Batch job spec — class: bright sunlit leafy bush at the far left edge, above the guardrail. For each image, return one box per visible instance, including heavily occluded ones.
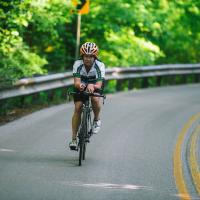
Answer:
[0,1,47,87]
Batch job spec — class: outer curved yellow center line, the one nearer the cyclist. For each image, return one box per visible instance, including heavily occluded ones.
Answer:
[173,113,200,200]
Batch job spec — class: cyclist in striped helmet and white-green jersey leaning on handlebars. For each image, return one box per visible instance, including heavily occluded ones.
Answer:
[69,42,105,150]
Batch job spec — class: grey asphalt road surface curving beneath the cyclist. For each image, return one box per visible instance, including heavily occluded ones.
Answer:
[0,84,200,200]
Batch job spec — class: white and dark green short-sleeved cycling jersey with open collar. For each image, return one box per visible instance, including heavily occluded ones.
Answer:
[73,59,105,84]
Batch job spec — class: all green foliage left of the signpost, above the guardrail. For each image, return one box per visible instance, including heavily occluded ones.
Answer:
[0,0,73,88]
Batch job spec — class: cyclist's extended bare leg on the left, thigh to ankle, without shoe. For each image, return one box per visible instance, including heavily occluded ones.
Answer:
[72,101,83,140]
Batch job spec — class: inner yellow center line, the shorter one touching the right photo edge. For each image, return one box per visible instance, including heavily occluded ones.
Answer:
[190,125,200,195]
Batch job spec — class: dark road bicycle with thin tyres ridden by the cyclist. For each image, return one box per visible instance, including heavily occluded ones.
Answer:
[68,91,106,166]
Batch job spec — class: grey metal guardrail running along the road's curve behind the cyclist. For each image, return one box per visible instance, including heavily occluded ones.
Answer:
[0,64,200,100]
